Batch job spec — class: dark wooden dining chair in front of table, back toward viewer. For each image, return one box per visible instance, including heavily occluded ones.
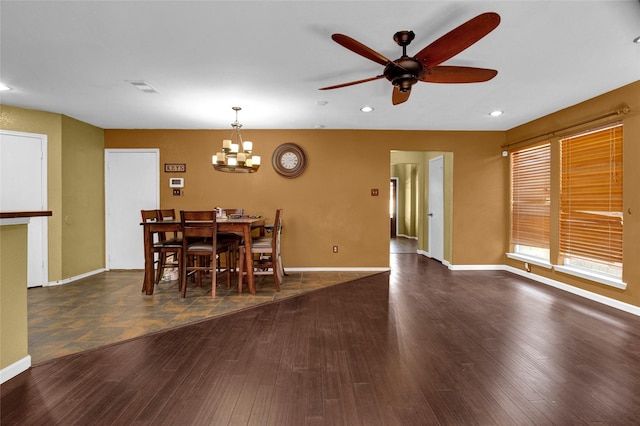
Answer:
[180,210,231,297]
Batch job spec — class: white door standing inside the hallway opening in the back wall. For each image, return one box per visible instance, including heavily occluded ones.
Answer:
[428,155,444,262]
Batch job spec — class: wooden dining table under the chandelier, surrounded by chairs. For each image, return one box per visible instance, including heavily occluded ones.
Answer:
[140,216,265,295]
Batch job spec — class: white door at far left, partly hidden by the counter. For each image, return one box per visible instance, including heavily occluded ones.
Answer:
[0,130,49,287]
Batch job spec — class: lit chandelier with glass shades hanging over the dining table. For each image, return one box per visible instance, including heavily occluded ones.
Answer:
[211,107,260,173]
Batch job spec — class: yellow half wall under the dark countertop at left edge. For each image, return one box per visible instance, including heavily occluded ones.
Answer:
[0,225,28,369]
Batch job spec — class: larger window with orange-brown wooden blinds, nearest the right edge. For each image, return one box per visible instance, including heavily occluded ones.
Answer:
[559,125,622,277]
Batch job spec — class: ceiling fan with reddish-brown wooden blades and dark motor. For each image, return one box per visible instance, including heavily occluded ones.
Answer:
[319,12,500,105]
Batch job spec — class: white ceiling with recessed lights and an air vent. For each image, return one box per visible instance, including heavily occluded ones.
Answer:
[0,0,640,130]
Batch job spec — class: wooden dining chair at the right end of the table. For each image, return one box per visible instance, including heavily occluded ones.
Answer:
[238,209,284,293]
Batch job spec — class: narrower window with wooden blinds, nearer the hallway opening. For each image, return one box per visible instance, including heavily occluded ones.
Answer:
[511,142,551,261]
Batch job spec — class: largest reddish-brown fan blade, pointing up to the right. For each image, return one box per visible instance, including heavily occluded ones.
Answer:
[414,12,500,69]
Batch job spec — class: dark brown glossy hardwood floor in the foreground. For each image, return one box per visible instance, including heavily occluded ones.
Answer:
[1,254,640,426]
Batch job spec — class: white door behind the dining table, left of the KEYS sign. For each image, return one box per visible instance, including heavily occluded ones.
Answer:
[105,149,160,270]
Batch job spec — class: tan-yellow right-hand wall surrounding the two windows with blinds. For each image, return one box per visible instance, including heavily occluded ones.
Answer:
[503,82,640,306]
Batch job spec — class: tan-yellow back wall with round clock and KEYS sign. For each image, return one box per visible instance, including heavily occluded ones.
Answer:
[105,129,506,268]
